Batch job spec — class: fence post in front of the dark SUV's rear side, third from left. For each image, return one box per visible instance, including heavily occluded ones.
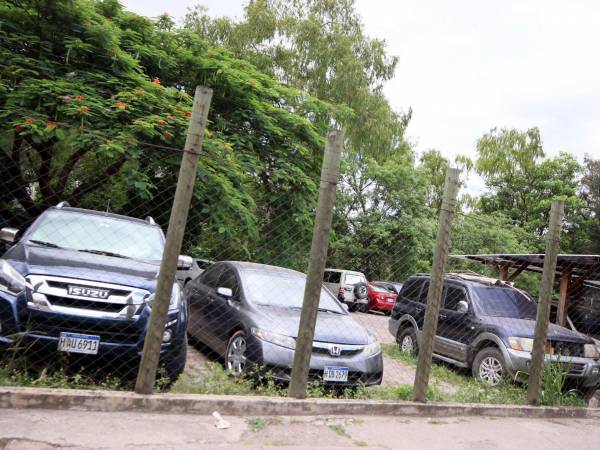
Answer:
[413,168,460,403]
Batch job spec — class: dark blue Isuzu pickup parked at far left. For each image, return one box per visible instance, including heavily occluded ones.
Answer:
[0,202,187,380]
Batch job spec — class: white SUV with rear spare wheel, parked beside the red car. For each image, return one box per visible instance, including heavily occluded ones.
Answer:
[323,269,369,312]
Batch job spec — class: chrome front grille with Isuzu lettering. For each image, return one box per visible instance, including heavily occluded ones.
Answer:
[27,275,150,319]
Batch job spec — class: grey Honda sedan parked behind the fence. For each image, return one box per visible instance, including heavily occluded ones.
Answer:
[185,261,383,386]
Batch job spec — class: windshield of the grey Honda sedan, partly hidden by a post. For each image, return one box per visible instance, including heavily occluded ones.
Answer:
[242,270,345,314]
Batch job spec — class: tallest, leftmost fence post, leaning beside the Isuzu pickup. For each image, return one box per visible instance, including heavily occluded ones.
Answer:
[135,86,212,394]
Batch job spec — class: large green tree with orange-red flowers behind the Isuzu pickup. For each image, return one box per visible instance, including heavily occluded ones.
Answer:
[0,0,336,259]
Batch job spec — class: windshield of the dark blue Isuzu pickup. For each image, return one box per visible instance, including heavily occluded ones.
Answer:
[28,211,164,261]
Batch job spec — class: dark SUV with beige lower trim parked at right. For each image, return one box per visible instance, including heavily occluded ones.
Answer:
[389,274,600,392]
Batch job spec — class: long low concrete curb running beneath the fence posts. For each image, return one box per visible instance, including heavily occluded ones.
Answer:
[0,388,600,419]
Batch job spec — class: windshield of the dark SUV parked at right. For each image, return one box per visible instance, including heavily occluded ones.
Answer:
[473,286,537,320]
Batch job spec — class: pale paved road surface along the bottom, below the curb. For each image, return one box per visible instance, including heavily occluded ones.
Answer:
[0,410,600,450]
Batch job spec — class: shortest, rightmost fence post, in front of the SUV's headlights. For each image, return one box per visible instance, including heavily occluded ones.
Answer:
[527,200,565,405]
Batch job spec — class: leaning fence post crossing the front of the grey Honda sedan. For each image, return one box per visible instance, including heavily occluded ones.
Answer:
[289,130,343,398]
